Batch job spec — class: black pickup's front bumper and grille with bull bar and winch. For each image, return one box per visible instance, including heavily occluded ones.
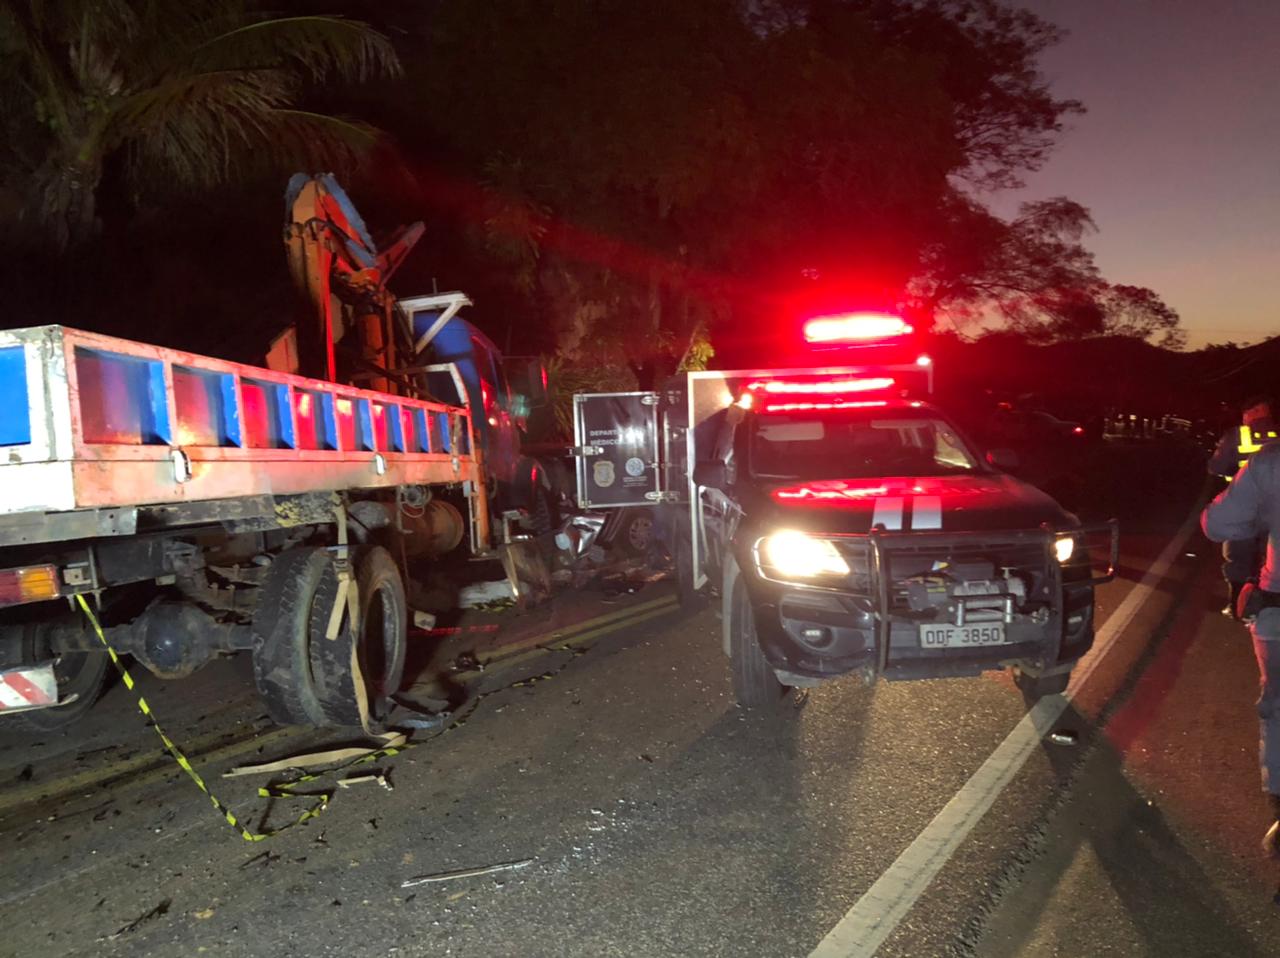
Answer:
[739,520,1119,685]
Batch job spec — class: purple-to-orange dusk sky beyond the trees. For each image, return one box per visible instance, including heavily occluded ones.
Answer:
[993,0,1280,348]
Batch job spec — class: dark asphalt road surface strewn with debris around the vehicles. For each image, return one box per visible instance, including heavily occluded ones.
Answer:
[0,438,1277,957]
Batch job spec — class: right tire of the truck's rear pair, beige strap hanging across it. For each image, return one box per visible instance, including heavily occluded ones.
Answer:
[311,547,408,726]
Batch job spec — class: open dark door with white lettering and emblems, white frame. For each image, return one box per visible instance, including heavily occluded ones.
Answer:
[573,392,662,508]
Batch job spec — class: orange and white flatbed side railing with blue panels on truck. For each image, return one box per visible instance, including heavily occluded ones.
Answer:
[0,325,481,516]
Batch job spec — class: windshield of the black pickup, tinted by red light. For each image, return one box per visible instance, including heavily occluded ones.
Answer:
[749,410,982,479]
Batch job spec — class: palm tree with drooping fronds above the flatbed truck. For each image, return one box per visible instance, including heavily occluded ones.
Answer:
[0,0,399,250]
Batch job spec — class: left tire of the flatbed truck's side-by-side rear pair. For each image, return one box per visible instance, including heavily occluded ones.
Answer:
[253,548,337,726]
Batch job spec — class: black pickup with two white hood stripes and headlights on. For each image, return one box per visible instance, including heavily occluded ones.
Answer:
[691,387,1117,706]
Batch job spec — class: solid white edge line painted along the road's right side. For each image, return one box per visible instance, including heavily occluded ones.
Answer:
[809,510,1199,958]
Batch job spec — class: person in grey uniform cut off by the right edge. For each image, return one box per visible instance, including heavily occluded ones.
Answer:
[1201,442,1280,857]
